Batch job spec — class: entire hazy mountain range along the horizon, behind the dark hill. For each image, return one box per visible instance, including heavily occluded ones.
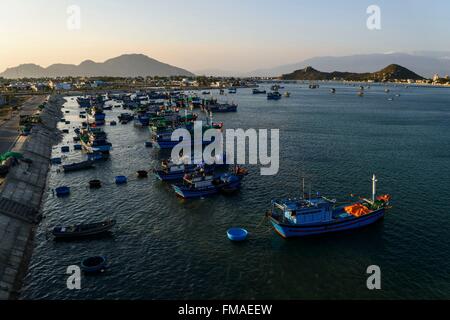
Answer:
[0,51,450,78]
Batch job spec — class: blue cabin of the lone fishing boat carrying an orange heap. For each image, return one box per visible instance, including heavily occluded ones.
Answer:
[272,197,334,224]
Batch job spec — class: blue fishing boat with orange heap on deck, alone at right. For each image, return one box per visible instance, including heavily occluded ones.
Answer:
[268,175,390,238]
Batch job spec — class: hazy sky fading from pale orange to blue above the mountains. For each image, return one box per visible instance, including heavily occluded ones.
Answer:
[0,0,450,71]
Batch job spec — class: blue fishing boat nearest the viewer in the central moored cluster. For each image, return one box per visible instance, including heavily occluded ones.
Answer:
[172,168,247,199]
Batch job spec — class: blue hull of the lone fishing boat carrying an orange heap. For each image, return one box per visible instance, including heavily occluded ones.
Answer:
[270,208,385,238]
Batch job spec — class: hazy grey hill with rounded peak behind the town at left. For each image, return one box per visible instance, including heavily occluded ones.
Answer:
[0,54,194,78]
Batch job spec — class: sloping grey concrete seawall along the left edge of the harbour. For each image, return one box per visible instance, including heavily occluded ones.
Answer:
[0,96,65,300]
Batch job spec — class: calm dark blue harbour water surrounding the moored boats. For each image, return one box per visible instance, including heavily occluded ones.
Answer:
[22,84,450,299]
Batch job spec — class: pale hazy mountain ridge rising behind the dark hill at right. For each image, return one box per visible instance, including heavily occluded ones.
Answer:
[247,52,450,78]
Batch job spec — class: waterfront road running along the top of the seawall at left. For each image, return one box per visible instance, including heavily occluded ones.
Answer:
[0,96,47,154]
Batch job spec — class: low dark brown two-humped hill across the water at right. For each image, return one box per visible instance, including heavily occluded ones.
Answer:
[281,64,424,82]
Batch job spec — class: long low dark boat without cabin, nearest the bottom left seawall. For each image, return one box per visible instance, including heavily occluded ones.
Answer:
[52,220,116,239]
